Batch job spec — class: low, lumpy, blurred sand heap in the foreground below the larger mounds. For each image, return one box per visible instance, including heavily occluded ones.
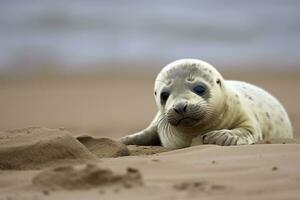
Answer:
[32,164,142,190]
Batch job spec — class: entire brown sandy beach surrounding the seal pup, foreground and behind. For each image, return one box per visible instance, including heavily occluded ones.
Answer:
[0,71,300,200]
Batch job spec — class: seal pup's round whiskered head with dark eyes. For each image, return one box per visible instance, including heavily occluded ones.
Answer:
[154,59,225,128]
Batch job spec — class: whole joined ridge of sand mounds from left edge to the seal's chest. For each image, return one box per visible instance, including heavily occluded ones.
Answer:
[0,127,167,170]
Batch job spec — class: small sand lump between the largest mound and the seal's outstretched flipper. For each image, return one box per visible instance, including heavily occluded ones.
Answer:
[77,135,130,158]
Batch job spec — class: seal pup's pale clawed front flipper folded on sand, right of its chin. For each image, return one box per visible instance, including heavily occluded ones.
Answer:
[202,128,255,146]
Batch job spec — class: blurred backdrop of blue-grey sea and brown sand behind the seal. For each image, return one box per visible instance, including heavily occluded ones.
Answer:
[0,0,300,137]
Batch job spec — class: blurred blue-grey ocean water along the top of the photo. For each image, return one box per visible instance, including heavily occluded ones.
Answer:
[0,0,300,70]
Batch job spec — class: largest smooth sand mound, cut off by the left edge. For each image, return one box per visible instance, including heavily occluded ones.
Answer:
[0,127,96,169]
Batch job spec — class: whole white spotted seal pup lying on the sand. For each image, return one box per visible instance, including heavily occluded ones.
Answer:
[121,59,293,149]
